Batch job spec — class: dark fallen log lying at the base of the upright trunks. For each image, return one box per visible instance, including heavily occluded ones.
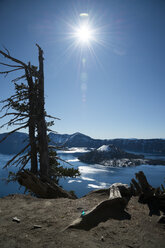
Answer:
[17,170,76,199]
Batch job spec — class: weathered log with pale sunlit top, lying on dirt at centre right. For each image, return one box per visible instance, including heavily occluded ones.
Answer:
[67,184,131,230]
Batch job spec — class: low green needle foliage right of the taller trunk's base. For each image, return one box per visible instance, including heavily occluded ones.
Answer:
[49,149,80,184]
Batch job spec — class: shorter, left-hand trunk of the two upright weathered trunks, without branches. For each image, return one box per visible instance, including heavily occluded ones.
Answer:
[25,66,38,174]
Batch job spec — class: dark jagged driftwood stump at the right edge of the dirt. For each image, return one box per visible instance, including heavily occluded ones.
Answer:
[131,171,165,216]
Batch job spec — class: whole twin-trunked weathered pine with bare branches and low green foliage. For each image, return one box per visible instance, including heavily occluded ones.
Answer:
[0,44,79,198]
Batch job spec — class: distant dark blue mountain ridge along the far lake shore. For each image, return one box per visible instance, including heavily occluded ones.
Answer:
[0,132,165,155]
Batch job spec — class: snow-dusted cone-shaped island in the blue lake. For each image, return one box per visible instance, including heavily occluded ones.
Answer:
[79,144,165,167]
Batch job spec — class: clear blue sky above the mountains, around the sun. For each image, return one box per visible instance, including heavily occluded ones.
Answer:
[0,0,165,138]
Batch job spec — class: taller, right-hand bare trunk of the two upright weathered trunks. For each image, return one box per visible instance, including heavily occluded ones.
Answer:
[37,45,49,177]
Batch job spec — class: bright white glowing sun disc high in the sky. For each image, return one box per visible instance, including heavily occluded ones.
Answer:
[75,25,93,44]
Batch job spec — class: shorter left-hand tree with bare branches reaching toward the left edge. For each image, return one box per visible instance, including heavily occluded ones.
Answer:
[0,51,37,171]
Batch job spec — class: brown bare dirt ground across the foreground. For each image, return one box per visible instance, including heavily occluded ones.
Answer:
[0,193,165,248]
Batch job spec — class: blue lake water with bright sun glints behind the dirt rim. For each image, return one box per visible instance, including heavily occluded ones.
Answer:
[0,153,165,197]
